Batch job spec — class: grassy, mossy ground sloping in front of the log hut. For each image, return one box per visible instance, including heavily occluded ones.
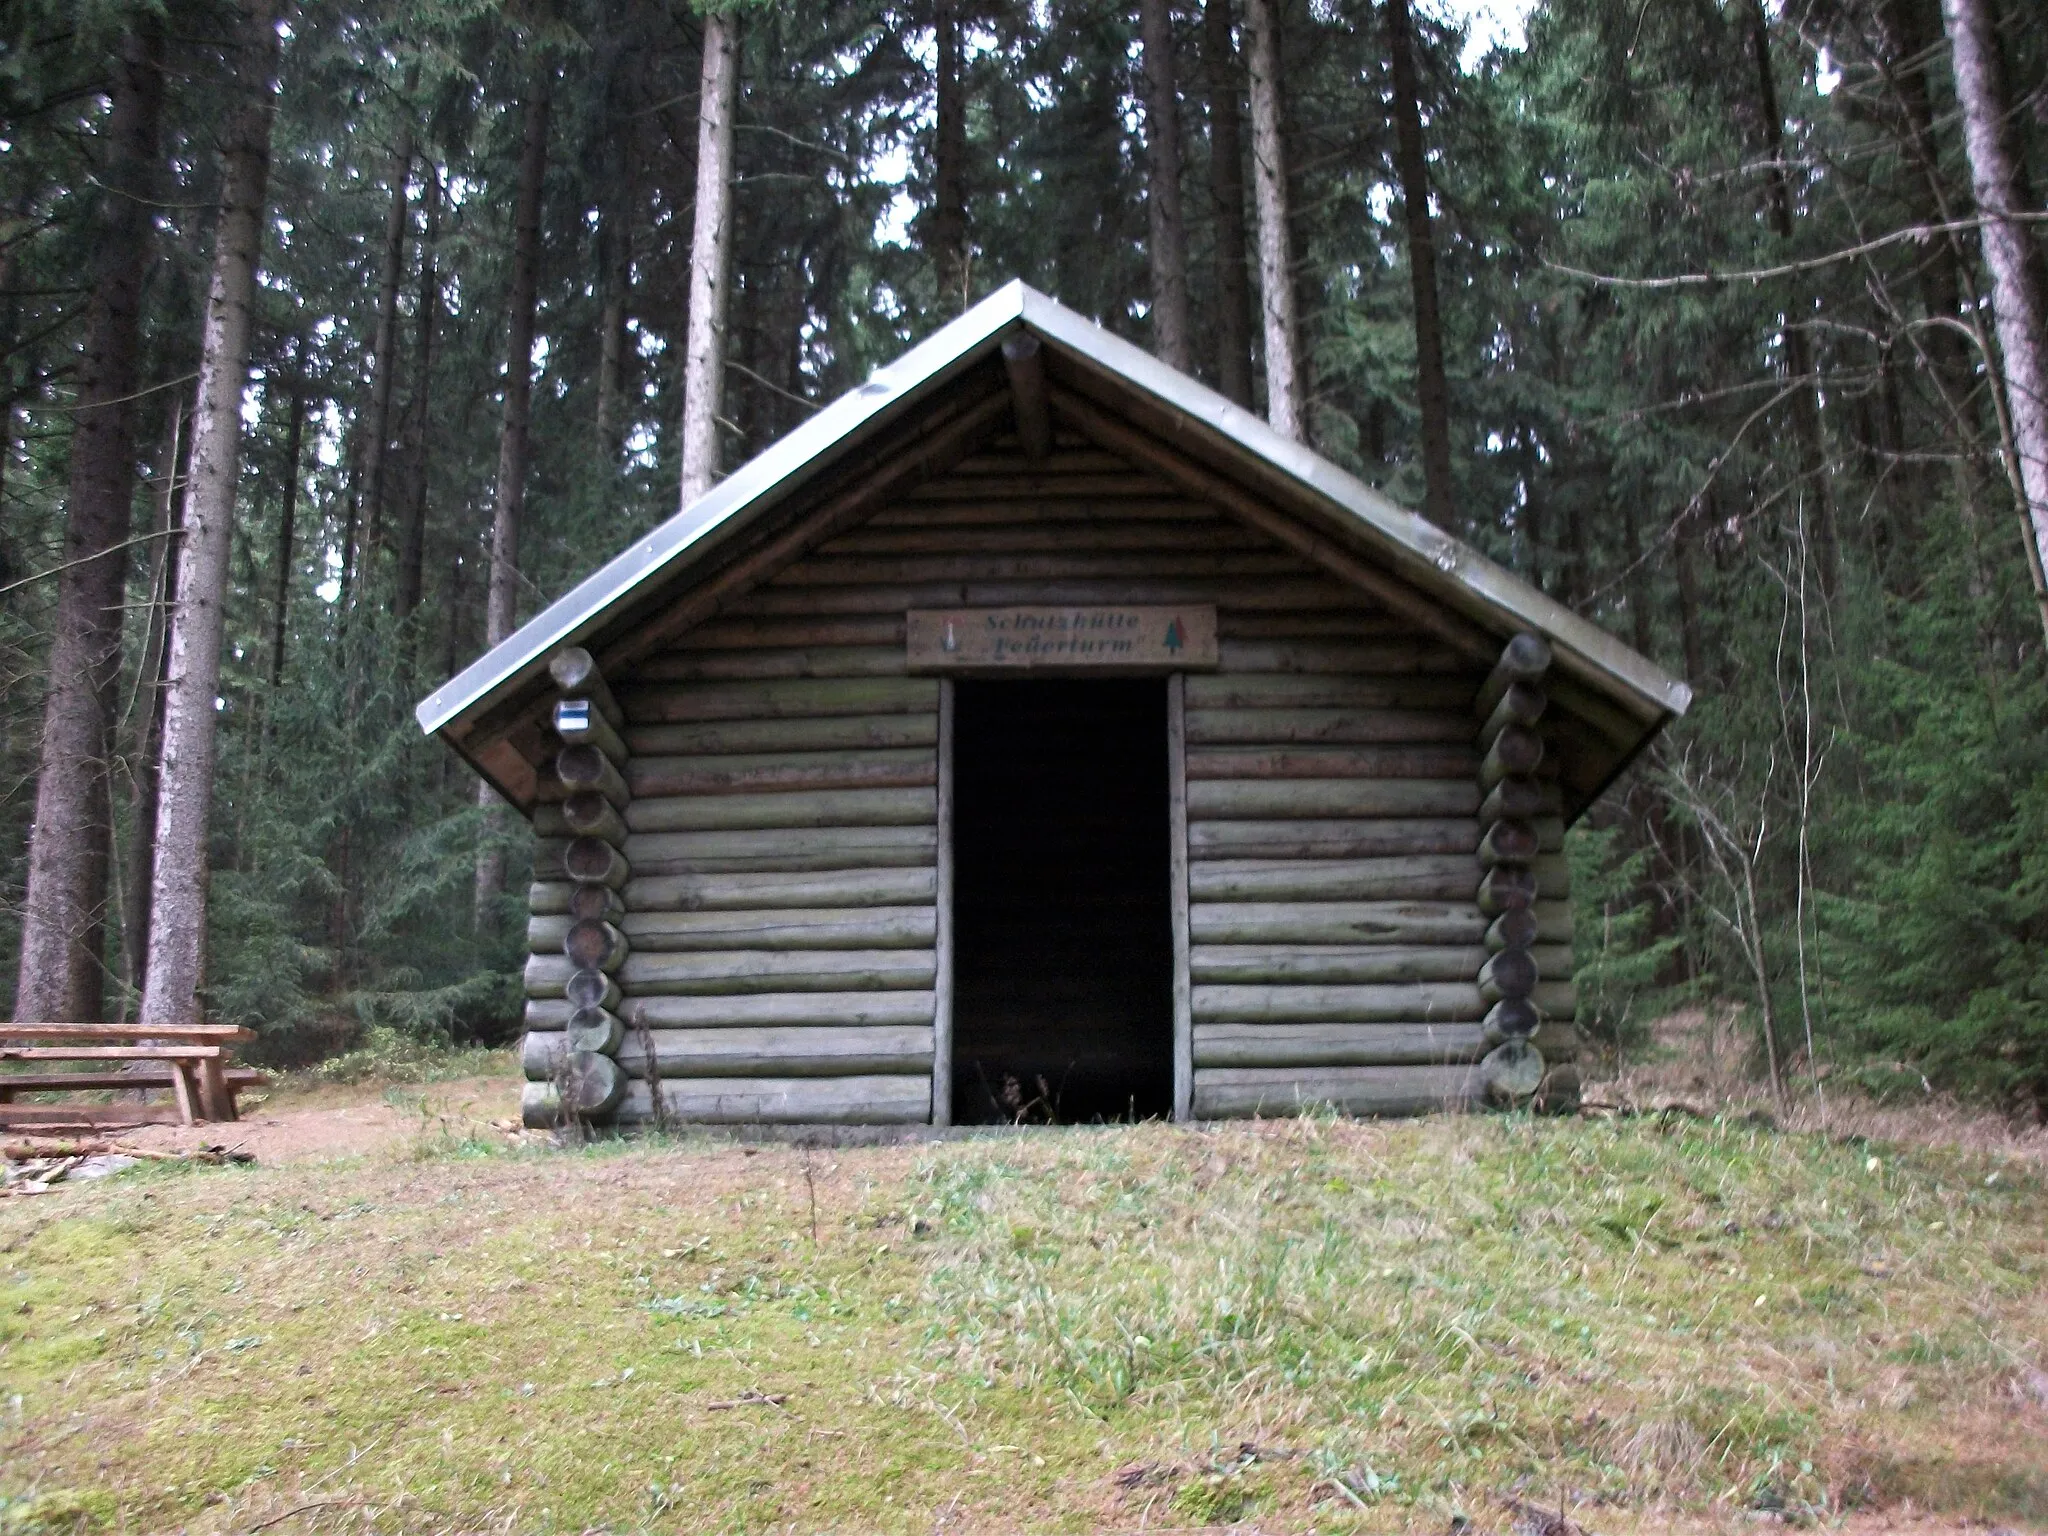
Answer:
[0,1061,2048,1536]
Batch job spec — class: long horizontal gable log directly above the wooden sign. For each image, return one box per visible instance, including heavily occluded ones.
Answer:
[743,575,1376,614]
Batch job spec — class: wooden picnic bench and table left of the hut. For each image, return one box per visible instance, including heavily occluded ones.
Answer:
[0,1024,268,1124]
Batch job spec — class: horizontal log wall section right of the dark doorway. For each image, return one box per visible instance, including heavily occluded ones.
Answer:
[1186,606,1575,1116]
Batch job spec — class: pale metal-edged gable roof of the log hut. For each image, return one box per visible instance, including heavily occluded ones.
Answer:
[414,283,1692,749]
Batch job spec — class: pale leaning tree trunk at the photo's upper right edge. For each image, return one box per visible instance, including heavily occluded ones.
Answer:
[1942,0,2048,633]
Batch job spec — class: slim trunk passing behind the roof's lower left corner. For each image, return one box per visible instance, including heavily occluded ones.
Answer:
[475,72,555,934]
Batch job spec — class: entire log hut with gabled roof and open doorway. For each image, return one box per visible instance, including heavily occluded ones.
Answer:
[418,285,1690,1124]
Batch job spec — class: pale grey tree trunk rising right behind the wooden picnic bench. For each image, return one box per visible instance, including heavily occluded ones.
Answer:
[141,0,279,1024]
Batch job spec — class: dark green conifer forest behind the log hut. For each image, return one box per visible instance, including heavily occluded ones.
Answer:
[0,0,2048,1114]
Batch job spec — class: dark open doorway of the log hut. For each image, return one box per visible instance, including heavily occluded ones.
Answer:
[952,678,1174,1124]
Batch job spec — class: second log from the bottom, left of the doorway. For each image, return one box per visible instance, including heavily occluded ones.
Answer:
[520,1024,932,1081]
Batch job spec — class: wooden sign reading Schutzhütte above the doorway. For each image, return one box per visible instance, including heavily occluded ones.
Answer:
[905,602,1217,672]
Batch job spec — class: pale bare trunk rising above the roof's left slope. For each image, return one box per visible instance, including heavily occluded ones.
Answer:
[682,10,739,506]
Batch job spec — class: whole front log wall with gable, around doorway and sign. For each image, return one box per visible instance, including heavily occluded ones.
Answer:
[526,442,1571,1122]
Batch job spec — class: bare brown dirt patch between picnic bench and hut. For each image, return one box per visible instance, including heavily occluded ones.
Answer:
[107,1077,520,1163]
